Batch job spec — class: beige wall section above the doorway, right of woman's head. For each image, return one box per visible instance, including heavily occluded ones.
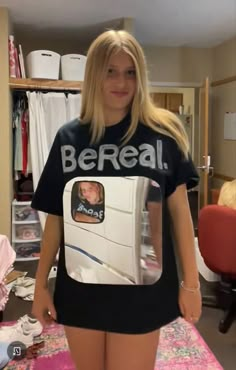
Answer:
[144,46,212,83]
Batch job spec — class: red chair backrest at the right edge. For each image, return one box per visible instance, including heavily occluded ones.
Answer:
[198,205,236,276]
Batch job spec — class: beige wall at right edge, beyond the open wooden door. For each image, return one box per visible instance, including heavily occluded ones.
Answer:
[212,38,236,187]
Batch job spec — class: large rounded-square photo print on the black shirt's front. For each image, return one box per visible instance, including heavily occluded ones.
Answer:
[63,176,162,285]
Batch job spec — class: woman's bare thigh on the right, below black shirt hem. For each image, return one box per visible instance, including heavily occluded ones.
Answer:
[105,330,160,370]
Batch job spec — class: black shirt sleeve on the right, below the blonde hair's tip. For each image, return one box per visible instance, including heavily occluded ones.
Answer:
[165,139,199,197]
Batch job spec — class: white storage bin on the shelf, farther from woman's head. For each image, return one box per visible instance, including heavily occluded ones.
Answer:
[26,50,61,80]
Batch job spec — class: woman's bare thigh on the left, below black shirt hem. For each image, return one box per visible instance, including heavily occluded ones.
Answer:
[64,326,105,370]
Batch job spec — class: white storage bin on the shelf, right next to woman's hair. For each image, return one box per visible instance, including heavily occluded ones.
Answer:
[61,54,87,81]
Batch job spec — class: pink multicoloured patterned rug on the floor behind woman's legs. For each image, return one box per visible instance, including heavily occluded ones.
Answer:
[1,318,223,370]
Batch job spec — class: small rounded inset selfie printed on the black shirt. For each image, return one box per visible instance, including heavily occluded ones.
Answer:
[71,181,105,223]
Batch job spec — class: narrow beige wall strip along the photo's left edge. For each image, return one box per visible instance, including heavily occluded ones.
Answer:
[0,8,12,237]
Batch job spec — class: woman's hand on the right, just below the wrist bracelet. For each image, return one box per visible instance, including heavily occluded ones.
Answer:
[179,286,202,324]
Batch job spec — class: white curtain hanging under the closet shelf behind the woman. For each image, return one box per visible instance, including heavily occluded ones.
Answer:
[27,92,81,228]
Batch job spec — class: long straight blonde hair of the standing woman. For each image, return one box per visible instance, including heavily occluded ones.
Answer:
[80,30,189,157]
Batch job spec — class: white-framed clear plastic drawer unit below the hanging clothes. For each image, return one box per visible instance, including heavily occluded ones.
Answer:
[12,200,42,261]
